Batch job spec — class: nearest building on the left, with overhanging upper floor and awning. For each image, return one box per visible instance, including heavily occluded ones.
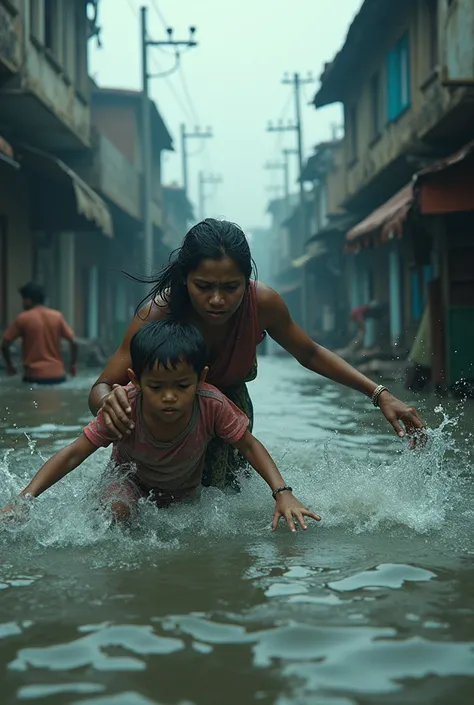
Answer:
[0,0,113,336]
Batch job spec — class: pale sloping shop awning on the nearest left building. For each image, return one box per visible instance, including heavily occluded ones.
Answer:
[21,146,113,237]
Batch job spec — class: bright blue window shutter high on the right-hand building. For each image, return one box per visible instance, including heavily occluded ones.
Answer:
[387,34,411,122]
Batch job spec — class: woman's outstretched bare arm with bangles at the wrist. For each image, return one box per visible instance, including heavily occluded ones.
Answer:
[258,284,423,437]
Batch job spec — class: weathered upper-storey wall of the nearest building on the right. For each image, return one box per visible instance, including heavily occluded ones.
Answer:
[344,0,474,204]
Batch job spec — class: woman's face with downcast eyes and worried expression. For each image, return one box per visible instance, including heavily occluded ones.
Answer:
[186,257,246,326]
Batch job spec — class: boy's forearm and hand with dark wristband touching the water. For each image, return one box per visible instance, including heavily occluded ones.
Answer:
[233,431,320,532]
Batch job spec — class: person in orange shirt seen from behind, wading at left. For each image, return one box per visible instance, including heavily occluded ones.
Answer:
[1,283,77,384]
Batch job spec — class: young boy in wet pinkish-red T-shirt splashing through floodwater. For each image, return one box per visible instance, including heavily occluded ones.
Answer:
[3,320,320,531]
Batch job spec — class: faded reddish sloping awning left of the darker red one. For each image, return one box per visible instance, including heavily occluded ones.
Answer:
[346,183,413,249]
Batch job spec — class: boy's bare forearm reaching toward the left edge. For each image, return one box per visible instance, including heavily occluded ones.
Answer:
[20,434,97,497]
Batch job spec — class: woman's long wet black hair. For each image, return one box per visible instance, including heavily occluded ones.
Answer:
[131,218,256,318]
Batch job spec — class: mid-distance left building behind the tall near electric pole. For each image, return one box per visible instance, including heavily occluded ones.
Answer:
[74,82,173,345]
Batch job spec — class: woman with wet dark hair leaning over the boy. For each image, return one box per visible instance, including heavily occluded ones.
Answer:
[89,218,423,486]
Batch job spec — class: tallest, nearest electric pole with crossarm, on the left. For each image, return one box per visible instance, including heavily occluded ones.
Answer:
[140,7,197,284]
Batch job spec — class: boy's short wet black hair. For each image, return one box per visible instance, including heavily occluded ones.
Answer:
[130,318,207,379]
